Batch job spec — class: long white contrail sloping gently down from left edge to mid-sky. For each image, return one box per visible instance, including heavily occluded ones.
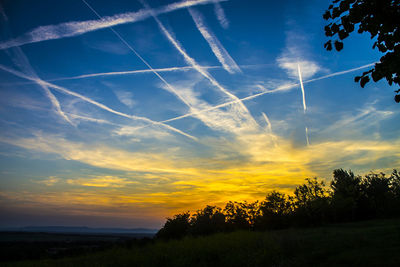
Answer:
[0,64,197,141]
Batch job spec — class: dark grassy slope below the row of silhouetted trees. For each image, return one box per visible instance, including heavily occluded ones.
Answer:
[5,219,400,266]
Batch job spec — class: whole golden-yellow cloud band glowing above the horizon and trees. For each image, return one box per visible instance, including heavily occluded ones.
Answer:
[3,131,400,222]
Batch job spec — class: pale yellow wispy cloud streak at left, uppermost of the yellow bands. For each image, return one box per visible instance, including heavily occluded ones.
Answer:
[0,132,196,174]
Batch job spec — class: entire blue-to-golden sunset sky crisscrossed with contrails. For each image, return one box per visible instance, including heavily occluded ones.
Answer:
[0,0,400,228]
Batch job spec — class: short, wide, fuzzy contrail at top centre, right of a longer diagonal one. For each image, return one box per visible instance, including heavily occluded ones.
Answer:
[188,7,241,73]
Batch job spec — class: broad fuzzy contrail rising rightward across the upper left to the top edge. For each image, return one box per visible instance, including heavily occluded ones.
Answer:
[0,0,227,49]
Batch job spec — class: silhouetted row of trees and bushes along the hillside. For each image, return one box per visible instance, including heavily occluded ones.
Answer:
[156,169,400,239]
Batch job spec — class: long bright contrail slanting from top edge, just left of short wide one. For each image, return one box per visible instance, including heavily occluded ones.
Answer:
[140,0,257,125]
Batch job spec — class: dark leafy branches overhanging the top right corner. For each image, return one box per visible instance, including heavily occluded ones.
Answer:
[323,0,400,103]
